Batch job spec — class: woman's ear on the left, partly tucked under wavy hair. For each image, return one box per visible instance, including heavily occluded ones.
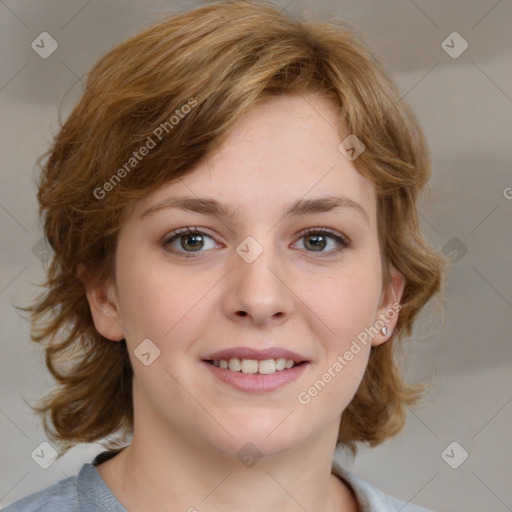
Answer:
[77,263,125,341]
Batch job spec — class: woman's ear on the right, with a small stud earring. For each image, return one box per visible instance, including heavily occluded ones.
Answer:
[372,266,405,347]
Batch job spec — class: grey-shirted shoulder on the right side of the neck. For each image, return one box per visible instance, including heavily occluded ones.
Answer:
[332,458,432,512]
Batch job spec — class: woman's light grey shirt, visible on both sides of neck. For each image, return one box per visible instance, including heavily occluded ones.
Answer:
[3,451,430,512]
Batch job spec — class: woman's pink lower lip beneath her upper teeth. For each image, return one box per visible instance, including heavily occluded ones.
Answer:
[202,361,309,393]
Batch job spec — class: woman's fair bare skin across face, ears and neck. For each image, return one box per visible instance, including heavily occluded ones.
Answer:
[80,94,404,512]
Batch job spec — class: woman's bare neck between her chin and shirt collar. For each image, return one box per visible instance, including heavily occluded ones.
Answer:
[98,422,358,512]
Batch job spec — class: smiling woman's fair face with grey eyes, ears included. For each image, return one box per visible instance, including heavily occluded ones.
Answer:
[84,94,403,455]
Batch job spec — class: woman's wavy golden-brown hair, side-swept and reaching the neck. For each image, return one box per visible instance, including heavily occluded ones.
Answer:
[24,0,449,457]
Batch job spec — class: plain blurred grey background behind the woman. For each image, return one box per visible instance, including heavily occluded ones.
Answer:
[0,0,512,512]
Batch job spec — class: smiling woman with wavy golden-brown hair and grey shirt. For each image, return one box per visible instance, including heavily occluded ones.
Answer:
[6,1,447,512]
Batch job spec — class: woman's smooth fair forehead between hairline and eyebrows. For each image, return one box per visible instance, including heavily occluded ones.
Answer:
[130,94,376,226]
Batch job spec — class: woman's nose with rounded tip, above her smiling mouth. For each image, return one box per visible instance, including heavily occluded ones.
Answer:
[224,239,294,327]
